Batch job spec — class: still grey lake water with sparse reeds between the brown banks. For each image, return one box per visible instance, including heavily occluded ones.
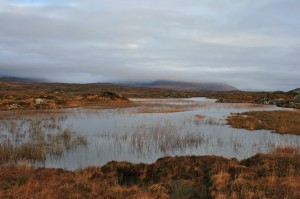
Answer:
[0,98,300,170]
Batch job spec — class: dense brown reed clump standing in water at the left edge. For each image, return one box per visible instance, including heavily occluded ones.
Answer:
[0,118,87,164]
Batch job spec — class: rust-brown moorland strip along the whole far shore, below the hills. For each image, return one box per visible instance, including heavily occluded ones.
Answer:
[0,81,299,110]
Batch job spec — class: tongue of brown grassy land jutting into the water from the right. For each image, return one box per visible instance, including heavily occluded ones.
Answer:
[228,110,300,135]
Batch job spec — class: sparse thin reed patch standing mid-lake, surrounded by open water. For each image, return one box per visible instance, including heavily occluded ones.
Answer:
[109,123,204,156]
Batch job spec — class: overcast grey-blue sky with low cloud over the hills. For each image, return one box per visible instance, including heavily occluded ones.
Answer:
[0,0,300,90]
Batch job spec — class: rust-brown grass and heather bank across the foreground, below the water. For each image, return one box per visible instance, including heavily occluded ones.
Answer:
[0,148,300,198]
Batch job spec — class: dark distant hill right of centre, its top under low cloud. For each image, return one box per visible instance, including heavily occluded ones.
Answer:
[131,80,239,92]
